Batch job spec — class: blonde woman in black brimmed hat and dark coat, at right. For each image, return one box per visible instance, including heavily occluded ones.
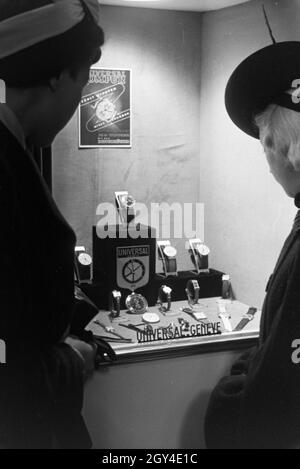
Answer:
[205,42,300,448]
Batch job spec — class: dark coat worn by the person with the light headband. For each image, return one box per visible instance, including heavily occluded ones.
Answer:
[0,123,90,448]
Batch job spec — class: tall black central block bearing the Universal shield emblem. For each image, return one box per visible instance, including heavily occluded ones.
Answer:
[92,224,156,309]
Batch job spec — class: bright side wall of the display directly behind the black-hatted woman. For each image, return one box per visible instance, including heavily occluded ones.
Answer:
[200,0,300,306]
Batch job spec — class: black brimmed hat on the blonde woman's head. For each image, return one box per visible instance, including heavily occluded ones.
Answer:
[225,41,300,139]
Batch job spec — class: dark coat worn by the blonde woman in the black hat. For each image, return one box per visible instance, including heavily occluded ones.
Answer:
[205,212,300,449]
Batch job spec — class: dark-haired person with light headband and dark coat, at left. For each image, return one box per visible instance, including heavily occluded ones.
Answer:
[0,0,104,449]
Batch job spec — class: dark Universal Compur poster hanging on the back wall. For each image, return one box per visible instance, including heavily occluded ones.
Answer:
[79,67,132,148]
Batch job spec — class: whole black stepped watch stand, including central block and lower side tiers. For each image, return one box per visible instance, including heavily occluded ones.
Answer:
[84,225,223,310]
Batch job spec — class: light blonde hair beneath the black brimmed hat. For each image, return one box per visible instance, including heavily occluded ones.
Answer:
[255,104,300,172]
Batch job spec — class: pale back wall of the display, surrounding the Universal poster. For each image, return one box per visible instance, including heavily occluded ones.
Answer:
[53,6,201,269]
